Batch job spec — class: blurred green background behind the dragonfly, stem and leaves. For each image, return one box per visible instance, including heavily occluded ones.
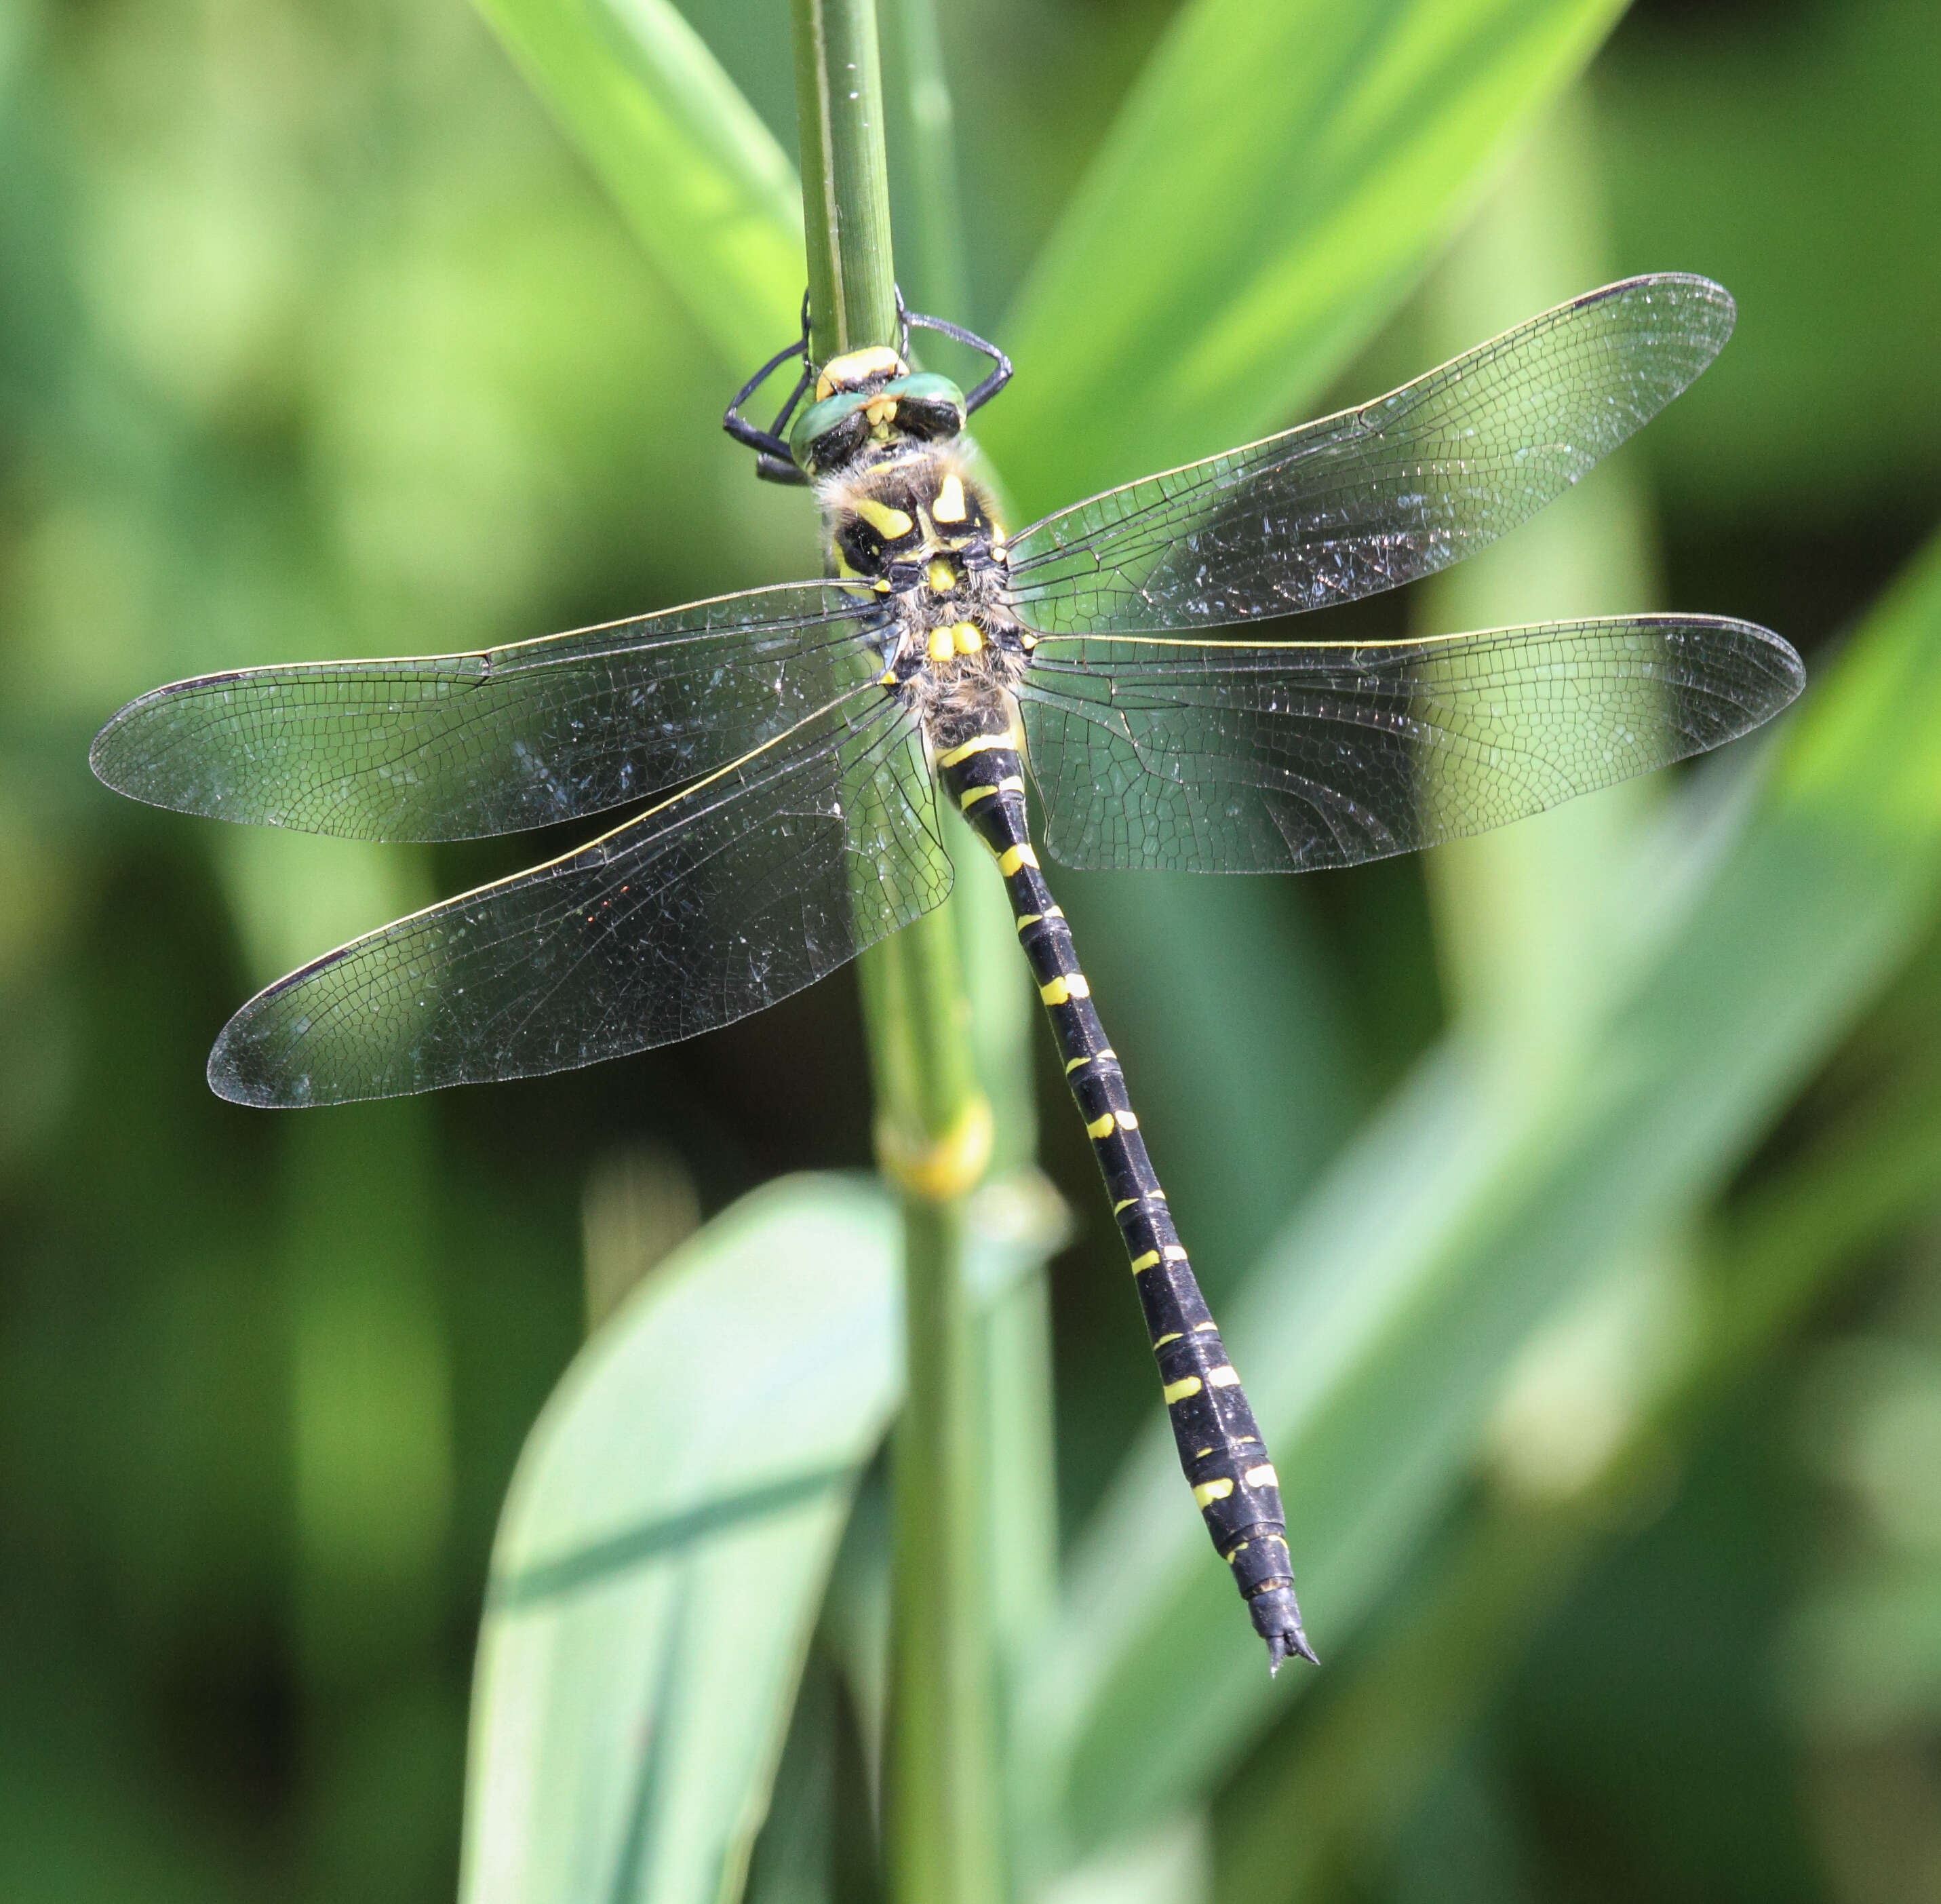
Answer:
[0,0,1941,1904]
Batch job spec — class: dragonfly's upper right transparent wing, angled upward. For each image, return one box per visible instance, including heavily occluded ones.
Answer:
[1009,275,1733,635]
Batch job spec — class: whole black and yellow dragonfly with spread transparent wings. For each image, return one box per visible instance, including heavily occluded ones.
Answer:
[92,273,1803,1669]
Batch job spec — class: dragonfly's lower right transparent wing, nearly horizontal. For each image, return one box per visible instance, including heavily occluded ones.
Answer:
[1021,615,1805,874]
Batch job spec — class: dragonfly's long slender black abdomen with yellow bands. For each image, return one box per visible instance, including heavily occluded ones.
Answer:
[937,734,1314,1671]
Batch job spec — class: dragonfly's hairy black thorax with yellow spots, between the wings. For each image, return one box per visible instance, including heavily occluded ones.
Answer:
[817,442,1031,747]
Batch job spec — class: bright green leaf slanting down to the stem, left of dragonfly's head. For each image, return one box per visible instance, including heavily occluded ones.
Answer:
[477,0,804,369]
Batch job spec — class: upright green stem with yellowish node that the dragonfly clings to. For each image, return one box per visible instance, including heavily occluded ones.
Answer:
[794,0,1000,1904]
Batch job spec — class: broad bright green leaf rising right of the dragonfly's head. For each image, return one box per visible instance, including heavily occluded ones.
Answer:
[978,0,1623,514]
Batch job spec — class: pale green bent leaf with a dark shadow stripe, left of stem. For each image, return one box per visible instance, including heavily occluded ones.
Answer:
[462,1178,903,1904]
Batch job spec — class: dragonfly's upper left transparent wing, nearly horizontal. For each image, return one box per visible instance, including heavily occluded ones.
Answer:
[90,582,876,840]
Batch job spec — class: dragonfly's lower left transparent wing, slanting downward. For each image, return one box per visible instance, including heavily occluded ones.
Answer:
[210,687,951,1106]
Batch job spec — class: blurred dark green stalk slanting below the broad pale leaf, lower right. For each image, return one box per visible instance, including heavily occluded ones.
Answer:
[1215,1001,1941,1904]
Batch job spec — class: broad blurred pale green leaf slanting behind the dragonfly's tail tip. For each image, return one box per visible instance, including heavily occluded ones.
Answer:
[1025,528,1941,1848]
